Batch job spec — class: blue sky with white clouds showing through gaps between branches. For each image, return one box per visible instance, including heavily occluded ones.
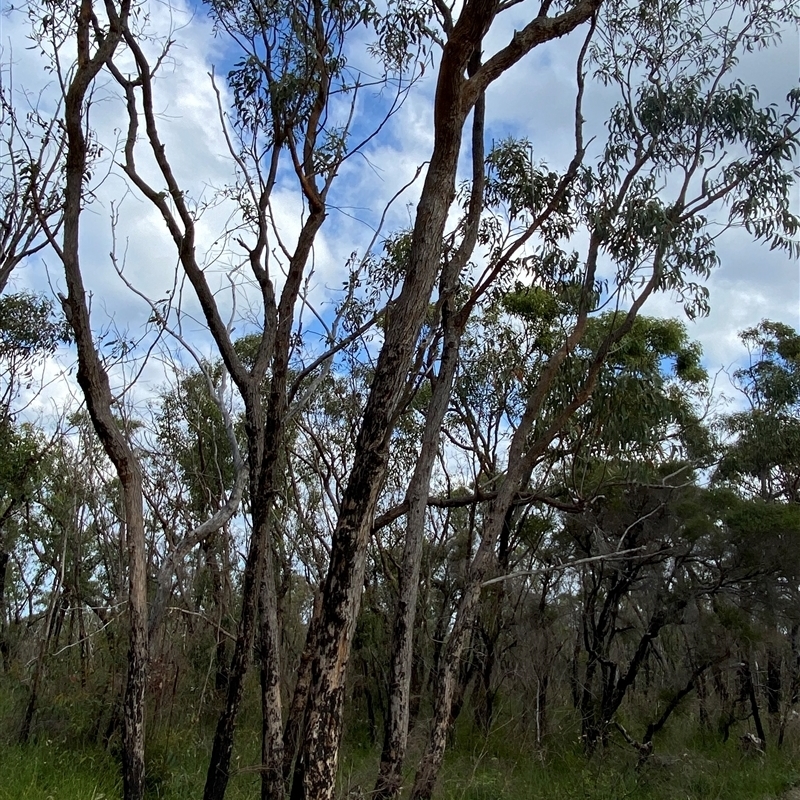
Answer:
[0,2,800,422]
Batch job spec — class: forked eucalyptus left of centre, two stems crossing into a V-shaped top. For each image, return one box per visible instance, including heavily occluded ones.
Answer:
[95,0,421,800]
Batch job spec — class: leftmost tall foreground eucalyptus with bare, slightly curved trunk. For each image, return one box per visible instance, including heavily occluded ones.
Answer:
[16,0,152,800]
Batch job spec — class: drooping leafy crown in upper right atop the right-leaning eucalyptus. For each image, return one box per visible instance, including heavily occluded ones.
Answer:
[580,0,798,316]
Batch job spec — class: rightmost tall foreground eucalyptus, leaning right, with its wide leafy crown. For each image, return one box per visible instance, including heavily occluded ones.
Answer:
[412,2,798,800]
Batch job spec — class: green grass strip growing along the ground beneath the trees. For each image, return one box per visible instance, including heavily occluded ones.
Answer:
[0,726,800,800]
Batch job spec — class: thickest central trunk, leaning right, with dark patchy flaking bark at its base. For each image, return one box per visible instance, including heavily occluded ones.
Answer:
[297,12,484,800]
